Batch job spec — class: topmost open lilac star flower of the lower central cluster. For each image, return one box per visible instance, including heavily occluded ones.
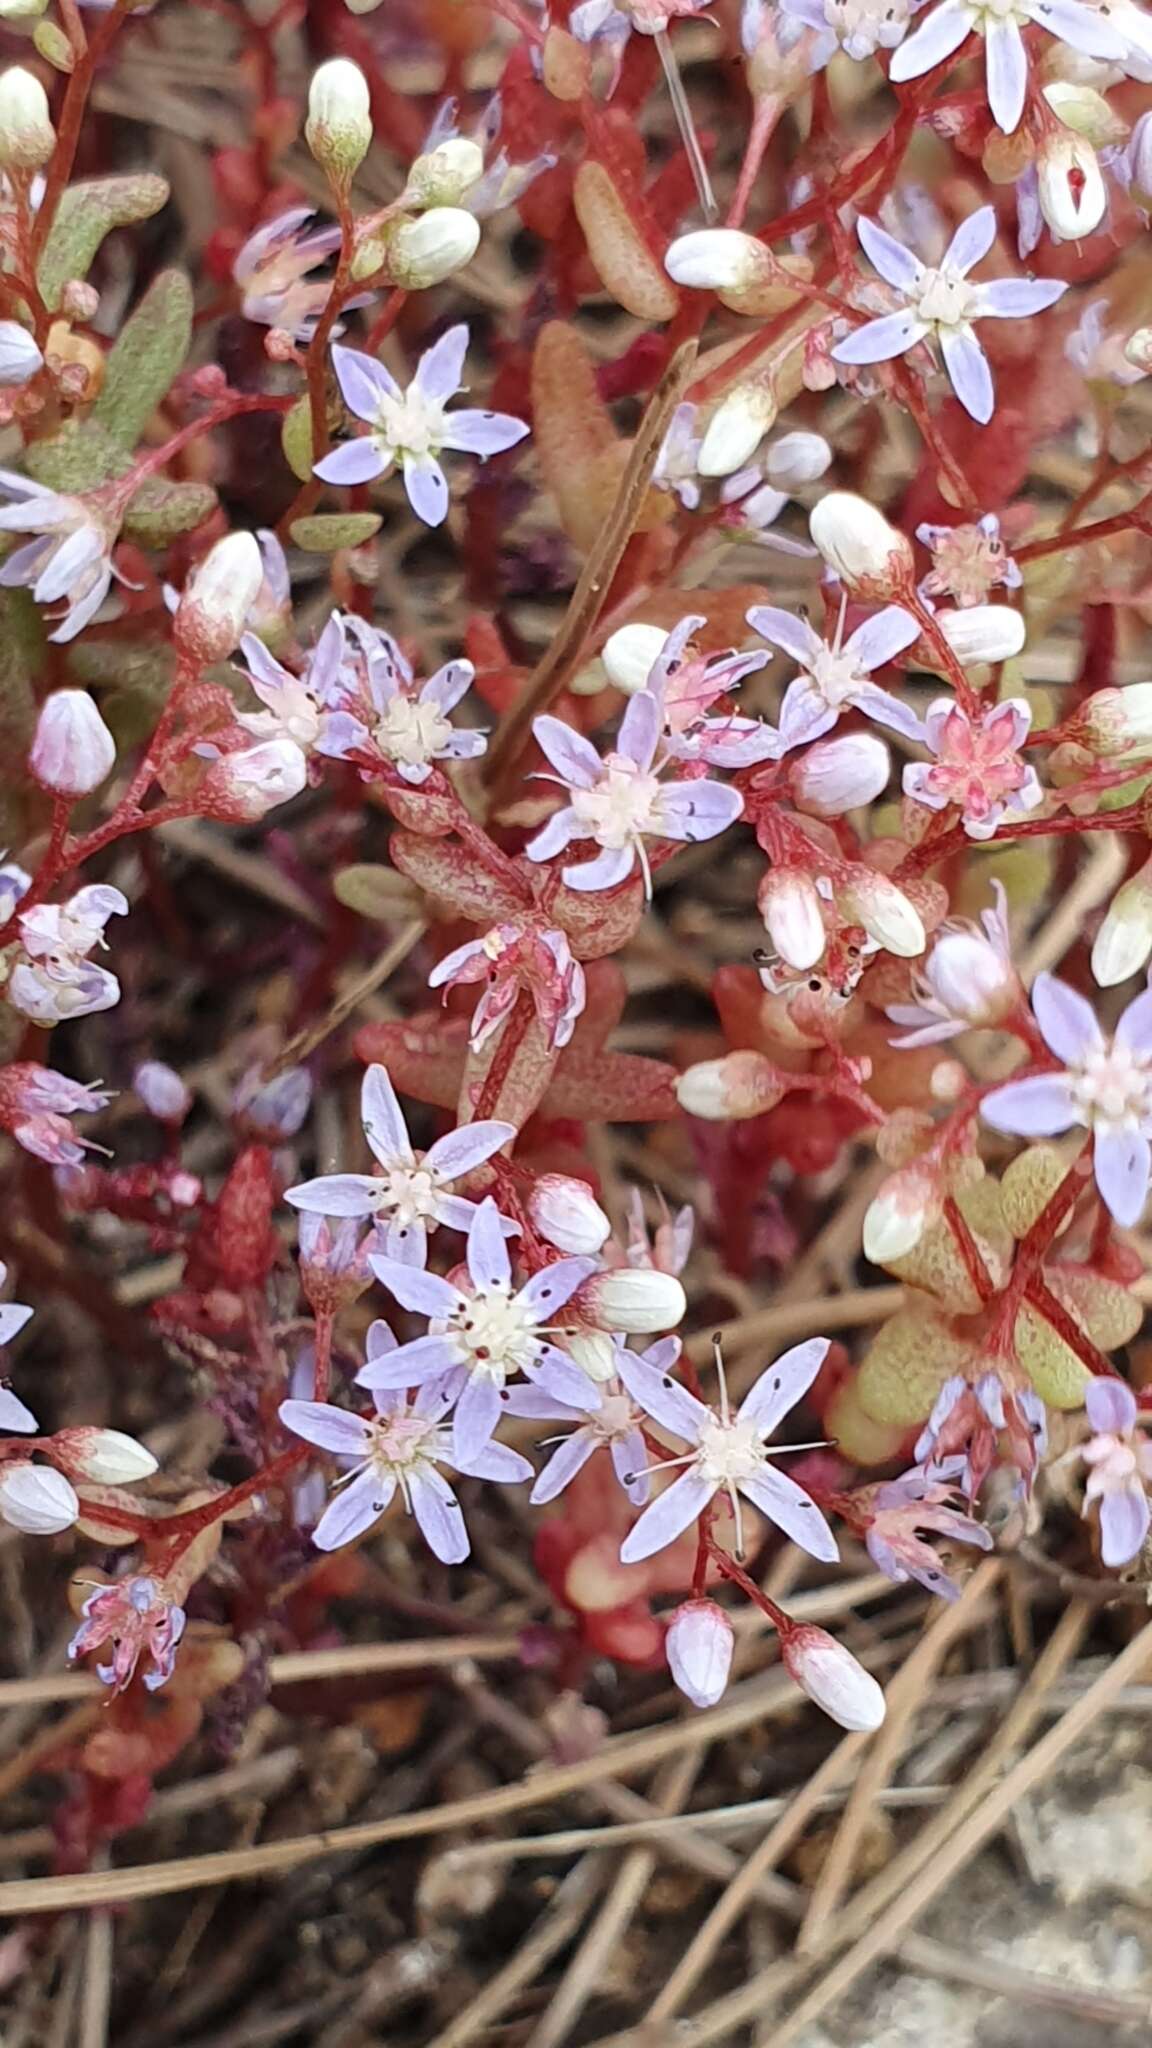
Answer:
[285,1067,517,1266]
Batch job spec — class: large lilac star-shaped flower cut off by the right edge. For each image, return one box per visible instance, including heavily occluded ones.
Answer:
[980,975,1152,1225]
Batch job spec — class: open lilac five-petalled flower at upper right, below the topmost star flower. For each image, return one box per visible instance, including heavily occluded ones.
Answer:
[832,208,1065,426]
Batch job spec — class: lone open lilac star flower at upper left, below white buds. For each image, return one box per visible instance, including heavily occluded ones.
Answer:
[316,324,529,526]
